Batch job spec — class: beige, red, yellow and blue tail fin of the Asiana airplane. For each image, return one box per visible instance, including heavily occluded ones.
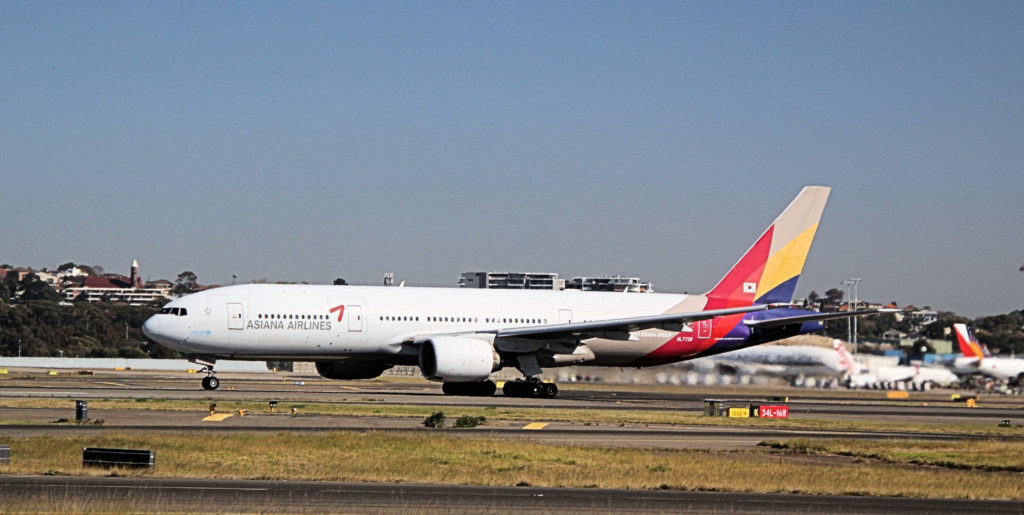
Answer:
[707,186,831,308]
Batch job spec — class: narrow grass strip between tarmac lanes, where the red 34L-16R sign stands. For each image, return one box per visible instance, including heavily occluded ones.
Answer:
[0,397,1024,436]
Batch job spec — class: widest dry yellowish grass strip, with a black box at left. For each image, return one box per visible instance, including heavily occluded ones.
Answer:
[6,432,1024,500]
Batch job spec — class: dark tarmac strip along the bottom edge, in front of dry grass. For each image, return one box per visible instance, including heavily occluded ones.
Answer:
[0,476,1024,514]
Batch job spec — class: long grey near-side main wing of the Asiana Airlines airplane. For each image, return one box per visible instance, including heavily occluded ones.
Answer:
[478,304,790,340]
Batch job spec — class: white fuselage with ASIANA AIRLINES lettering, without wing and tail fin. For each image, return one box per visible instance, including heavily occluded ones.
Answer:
[145,285,820,366]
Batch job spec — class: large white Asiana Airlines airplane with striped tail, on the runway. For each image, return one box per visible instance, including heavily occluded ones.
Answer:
[142,186,865,397]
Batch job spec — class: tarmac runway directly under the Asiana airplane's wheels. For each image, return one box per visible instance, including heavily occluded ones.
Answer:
[6,372,1024,426]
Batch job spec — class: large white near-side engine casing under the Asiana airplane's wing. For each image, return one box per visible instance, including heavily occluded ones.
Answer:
[420,336,501,383]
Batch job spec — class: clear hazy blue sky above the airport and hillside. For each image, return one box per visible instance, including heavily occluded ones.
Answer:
[0,1,1024,315]
